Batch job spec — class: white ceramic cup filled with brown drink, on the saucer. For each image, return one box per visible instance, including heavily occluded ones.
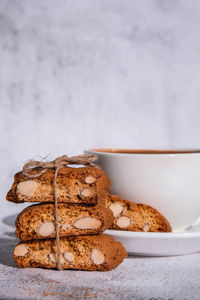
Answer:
[85,149,200,231]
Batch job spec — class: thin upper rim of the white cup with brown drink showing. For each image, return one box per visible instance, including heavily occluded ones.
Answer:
[84,148,200,156]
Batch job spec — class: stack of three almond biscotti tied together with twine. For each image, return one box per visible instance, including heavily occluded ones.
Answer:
[7,166,127,271]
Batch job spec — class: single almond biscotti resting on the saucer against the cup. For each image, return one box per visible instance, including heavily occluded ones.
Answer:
[106,195,172,232]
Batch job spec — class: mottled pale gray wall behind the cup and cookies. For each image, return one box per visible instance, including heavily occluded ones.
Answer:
[0,0,200,213]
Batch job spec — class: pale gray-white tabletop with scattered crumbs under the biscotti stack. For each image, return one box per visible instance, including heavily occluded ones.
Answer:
[0,204,200,300]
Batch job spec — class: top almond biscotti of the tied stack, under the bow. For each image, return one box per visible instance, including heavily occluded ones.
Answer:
[7,167,110,205]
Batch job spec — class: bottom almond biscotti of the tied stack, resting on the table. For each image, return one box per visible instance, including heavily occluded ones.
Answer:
[13,234,127,271]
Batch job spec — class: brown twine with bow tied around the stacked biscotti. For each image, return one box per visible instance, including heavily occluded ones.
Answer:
[22,155,97,270]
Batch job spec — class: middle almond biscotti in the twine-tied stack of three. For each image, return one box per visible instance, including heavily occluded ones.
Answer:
[15,203,114,240]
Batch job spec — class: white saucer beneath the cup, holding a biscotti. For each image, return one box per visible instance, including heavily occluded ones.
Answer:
[105,225,200,256]
